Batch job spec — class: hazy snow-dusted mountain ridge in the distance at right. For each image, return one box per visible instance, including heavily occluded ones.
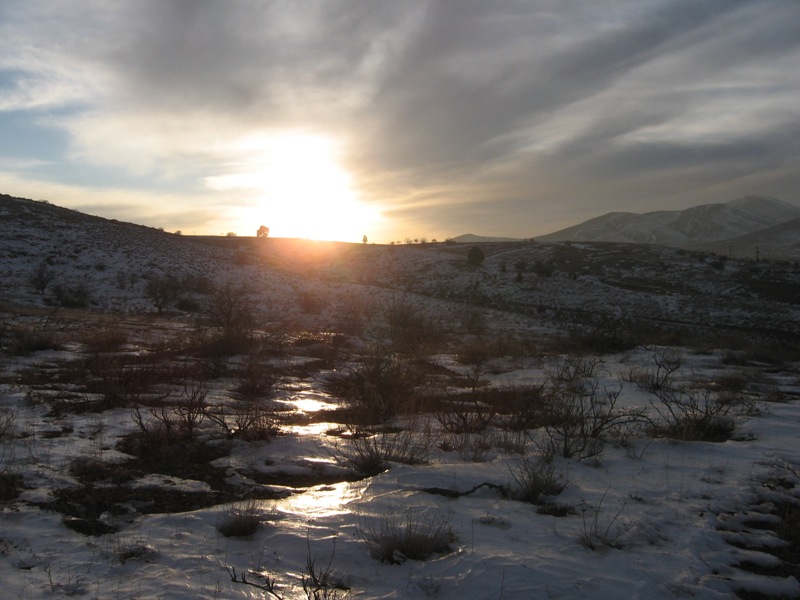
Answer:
[536,196,800,255]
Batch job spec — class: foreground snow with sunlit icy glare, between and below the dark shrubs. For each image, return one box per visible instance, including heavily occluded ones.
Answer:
[0,328,800,598]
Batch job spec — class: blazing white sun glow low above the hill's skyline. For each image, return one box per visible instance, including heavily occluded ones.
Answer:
[206,132,381,241]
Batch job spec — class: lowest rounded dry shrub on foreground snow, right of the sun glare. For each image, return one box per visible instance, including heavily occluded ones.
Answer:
[361,509,456,564]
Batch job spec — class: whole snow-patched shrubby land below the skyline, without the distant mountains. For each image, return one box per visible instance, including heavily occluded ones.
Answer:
[0,196,800,600]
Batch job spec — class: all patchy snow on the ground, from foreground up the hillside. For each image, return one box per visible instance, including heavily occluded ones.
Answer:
[0,195,800,600]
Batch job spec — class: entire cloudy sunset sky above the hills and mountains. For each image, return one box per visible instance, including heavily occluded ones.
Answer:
[0,0,800,242]
